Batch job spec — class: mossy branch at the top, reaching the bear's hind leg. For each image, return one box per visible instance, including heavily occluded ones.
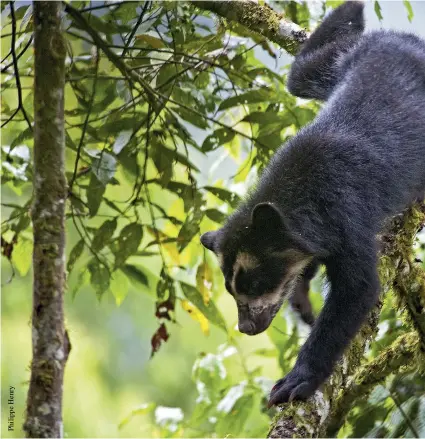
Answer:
[191,0,308,55]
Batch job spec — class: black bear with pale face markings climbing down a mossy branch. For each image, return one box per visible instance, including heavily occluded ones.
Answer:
[201,2,425,405]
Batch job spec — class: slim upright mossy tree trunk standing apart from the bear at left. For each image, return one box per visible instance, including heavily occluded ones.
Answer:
[24,1,70,437]
